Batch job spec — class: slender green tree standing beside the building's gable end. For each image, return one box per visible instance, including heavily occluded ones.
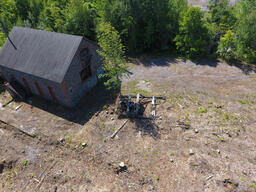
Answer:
[97,22,128,89]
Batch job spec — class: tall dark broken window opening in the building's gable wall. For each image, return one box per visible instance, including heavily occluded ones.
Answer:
[80,47,92,81]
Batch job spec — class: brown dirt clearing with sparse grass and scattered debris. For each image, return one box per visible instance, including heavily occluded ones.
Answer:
[0,59,256,192]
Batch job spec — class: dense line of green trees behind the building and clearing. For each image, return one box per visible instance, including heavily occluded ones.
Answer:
[0,0,256,88]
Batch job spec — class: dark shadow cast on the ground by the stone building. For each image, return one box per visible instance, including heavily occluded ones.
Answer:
[24,83,118,125]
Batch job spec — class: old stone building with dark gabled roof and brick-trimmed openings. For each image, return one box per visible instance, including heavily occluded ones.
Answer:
[0,27,103,107]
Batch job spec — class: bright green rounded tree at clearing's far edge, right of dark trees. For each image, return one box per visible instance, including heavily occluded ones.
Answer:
[174,7,209,58]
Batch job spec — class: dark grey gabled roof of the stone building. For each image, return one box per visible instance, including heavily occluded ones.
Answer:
[0,27,83,83]
